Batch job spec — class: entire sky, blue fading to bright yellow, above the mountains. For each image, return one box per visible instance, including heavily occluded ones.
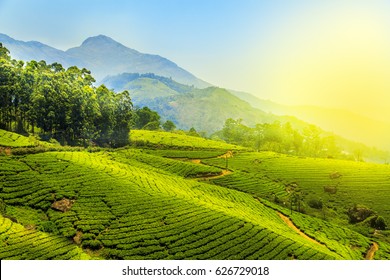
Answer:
[0,0,390,120]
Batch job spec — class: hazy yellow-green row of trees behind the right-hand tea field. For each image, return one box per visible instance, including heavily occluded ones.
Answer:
[220,119,340,157]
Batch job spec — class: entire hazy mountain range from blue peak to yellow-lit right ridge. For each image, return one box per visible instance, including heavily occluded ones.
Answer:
[0,34,390,150]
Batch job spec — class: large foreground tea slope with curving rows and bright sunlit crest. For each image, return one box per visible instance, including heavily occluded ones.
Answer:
[0,131,380,259]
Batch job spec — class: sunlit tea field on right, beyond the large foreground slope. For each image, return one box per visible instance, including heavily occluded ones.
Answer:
[203,152,390,229]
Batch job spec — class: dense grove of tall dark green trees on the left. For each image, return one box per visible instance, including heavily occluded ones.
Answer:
[0,43,175,147]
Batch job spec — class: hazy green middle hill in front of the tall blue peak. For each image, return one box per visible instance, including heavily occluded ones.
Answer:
[103,73,304,133]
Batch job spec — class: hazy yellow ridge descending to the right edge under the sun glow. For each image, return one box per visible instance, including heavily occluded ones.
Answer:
[231,91,390,150]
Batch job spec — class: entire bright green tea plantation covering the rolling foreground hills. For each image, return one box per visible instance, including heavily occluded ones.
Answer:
[0,131,390,259]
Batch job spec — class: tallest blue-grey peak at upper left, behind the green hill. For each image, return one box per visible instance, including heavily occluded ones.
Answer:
[0,34,210,88]
